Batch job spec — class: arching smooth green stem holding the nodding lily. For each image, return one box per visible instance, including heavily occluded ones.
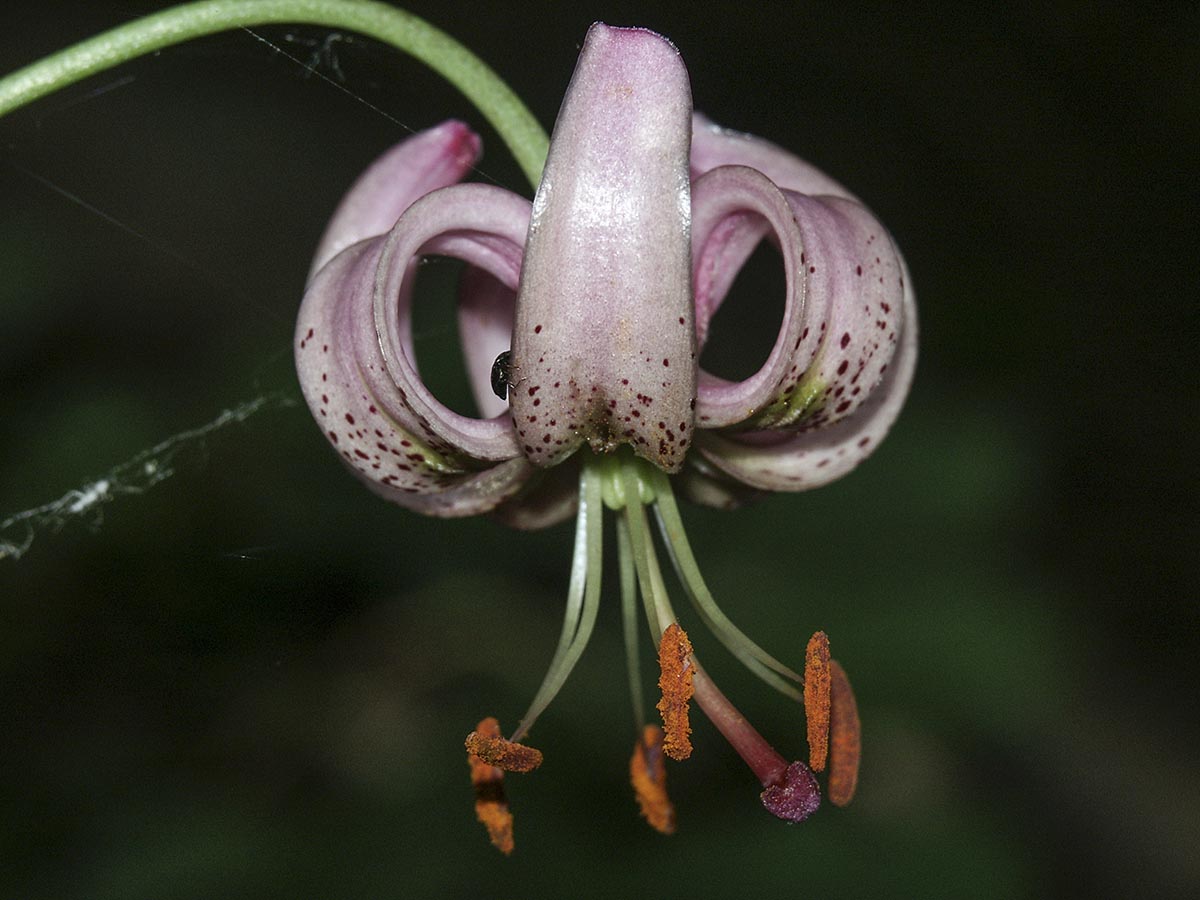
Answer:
[0,0,548,187]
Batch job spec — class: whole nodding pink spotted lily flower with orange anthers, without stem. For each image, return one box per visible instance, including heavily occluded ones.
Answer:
[295,24,916,852]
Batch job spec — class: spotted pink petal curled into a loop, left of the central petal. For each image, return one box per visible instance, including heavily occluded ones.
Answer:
[296,185,534,516]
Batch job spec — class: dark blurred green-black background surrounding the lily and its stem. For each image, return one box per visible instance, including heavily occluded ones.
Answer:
[0,0,1200,898]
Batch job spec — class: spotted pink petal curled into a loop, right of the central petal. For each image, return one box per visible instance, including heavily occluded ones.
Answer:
[692,166,905,439]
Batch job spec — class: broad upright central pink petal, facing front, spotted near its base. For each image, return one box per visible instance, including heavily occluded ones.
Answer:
[511,24,696,472]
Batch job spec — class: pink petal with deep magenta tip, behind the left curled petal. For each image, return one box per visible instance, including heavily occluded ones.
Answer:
[308,120,480,281]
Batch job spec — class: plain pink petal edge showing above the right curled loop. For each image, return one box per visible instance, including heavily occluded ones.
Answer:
[691,113,854,200]
